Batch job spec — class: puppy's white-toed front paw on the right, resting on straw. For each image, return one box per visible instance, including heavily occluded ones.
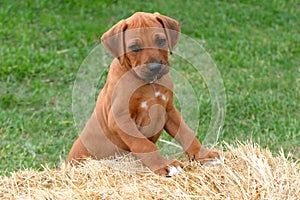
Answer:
[190,147,222,165]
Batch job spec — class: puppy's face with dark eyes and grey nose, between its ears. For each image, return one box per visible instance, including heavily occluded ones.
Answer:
[125,26,170,83]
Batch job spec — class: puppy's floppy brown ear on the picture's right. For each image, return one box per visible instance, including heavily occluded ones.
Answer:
[154,12,180,54]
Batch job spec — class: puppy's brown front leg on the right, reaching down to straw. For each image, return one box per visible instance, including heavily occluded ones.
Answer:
[164,106,220,164]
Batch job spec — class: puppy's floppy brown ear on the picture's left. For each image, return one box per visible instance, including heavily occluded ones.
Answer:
[101,20,127,63]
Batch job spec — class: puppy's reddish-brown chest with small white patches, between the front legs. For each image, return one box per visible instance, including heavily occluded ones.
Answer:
[130,85,170,137]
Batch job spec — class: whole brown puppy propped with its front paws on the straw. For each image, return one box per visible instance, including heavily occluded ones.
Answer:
[67,12,220,175]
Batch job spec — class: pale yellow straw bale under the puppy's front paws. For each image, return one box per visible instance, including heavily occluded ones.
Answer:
[0,144,300,199]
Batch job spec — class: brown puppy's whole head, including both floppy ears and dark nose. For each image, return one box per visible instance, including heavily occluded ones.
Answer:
[101,12,180,83]
